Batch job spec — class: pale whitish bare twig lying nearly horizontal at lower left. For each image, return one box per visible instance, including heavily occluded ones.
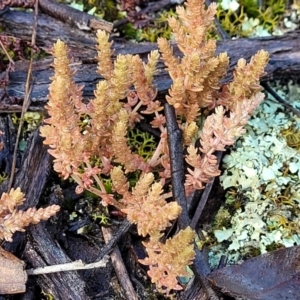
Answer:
[26,256,108,275]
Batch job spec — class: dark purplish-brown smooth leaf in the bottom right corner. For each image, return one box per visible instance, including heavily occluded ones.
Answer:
[209,246,300,300]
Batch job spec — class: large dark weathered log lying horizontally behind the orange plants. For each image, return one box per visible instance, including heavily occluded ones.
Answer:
[0,11,300,112]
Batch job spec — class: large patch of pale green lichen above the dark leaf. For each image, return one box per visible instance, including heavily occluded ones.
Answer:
[209,84,300,267]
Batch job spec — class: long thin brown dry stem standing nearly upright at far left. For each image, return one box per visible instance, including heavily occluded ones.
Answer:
[8,1,39,192]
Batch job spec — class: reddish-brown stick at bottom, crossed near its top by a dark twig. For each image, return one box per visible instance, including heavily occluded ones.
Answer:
[102,227,138,300]
